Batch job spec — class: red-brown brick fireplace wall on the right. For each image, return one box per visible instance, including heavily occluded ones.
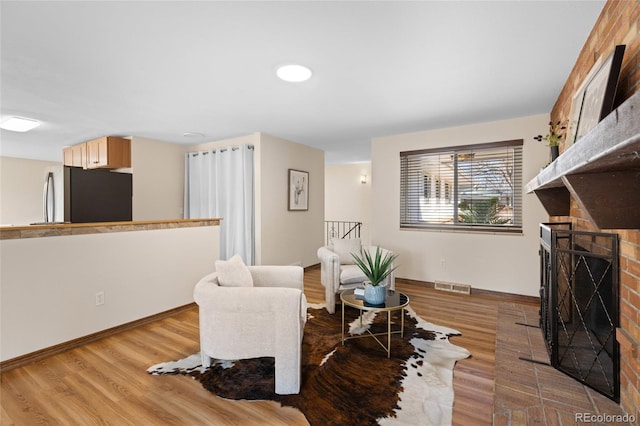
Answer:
[551,0,640,419]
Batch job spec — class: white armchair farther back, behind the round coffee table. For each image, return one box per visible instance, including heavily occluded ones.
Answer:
[318,238,396,314]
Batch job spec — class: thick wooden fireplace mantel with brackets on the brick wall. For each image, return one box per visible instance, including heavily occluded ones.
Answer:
[526,92,640,229]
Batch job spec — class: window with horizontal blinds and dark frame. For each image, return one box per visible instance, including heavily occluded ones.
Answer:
[400,140,523,232]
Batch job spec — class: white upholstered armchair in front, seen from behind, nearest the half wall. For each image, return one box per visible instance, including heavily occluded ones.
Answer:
[193,262,307,395]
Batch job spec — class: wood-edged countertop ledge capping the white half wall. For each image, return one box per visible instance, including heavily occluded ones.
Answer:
[0,218,221,240]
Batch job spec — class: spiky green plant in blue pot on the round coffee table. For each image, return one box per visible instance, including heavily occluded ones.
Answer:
[351,246,398,305]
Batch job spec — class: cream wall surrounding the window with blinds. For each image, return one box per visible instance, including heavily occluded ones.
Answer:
[372,115,549,296]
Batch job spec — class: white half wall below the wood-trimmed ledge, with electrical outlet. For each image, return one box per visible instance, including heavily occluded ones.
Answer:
[0,226,219,361]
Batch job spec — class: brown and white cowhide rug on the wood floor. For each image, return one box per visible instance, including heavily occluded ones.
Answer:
[147,305,470,425]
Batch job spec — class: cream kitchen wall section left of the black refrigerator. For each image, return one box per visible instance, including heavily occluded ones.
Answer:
[0,154,62,225]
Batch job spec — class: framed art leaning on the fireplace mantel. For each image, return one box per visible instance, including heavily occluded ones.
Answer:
[572,45,625,141]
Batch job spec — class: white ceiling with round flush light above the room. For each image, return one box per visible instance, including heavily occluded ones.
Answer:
[0,0,604,164]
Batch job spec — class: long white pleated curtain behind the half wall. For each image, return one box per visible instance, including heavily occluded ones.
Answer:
[184,145,254,265]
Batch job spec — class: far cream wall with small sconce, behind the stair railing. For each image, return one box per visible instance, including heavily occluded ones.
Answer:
[324,163,375,245]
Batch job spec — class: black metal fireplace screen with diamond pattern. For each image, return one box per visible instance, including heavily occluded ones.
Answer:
[540,223,620,402]
